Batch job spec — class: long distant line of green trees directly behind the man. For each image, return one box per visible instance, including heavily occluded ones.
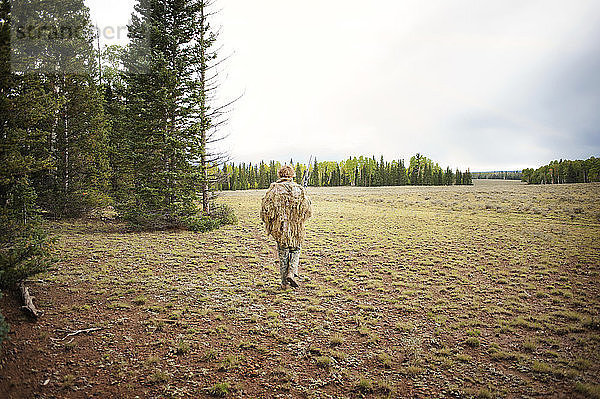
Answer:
[219,154,473,190]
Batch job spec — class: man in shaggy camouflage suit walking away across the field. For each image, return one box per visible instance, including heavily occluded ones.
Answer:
[260,165,312,289]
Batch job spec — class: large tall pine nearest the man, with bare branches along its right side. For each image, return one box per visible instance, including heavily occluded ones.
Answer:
[121,0,232,228]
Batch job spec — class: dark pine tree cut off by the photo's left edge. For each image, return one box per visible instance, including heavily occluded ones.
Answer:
[0,0,52,294]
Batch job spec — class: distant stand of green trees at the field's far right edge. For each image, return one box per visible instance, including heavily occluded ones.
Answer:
[522,157,600,184]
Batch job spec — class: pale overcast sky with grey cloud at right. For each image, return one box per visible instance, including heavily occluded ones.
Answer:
[86,0,600,171]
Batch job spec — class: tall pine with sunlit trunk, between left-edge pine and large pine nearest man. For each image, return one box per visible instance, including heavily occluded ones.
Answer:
[11,0,109,216]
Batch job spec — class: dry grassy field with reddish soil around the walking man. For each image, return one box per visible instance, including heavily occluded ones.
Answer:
[0,181,600,398]
